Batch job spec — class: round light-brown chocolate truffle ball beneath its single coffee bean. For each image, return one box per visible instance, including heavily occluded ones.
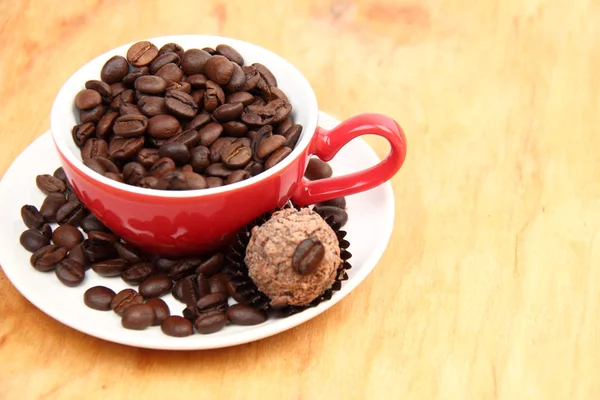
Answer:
[244,208,342,308]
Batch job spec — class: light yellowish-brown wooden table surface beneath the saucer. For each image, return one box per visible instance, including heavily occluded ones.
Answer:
[0,0,600,400]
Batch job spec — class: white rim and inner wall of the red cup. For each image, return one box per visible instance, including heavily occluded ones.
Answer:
[50,35,319,198]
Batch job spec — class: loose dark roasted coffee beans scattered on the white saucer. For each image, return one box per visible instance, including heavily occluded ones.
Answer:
[20,159,348,337]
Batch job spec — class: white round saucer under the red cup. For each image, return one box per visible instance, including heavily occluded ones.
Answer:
[0,113,394,350]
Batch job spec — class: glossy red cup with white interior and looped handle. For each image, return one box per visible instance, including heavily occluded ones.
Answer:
[50,35,406,257]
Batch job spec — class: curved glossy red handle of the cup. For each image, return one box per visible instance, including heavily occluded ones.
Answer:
[292,114,406,206]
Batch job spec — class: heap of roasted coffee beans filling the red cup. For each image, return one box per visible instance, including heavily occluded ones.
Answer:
[72,41,302,190]
